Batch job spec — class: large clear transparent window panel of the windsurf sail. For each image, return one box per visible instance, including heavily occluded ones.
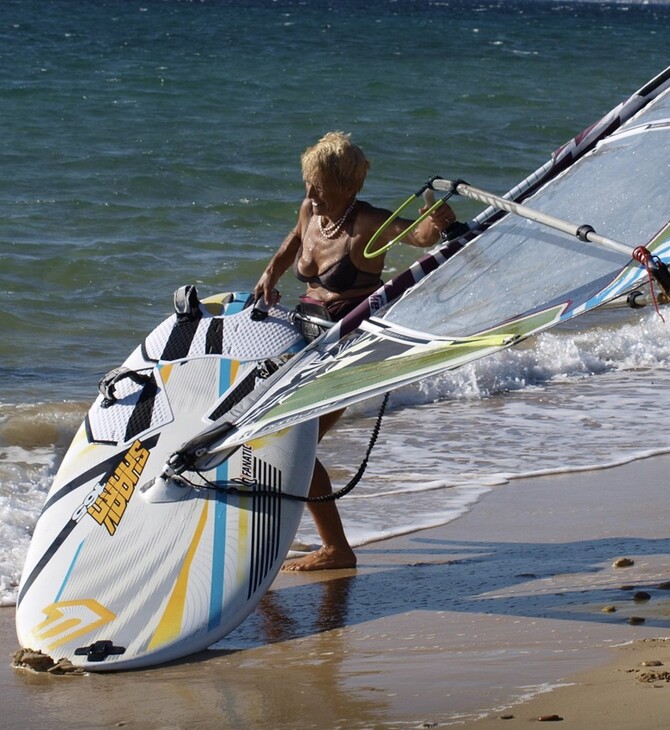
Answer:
[384,86,670,337]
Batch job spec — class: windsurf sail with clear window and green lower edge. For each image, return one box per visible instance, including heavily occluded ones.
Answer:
[181,68,670,466]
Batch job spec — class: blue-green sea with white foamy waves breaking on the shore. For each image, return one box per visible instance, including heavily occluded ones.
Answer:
[0,0,670,606]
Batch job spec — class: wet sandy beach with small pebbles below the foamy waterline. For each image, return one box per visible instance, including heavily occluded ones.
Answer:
[5,456,670,730]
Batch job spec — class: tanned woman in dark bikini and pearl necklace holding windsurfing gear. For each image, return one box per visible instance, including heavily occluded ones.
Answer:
[254,132,456,570]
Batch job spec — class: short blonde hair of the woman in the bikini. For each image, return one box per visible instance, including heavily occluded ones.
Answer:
[300,132,370,195]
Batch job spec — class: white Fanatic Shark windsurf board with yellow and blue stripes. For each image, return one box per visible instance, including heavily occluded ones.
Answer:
[16,287,317,671]
